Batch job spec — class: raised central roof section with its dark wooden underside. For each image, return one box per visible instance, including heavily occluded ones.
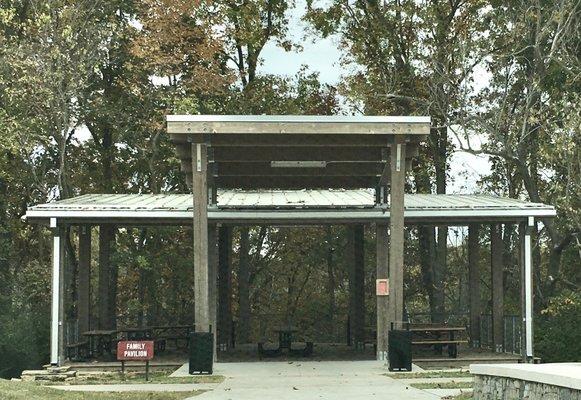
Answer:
[167,115,430,189]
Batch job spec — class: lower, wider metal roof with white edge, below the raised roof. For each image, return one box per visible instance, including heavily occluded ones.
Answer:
[25,190,556,225]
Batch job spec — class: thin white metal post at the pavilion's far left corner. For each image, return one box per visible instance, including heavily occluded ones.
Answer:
[50,218,61,365]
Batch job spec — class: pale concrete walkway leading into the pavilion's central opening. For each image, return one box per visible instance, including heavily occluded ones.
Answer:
[173,361,440,400]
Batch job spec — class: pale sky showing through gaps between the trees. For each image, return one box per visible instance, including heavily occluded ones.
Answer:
[259,0,490,194]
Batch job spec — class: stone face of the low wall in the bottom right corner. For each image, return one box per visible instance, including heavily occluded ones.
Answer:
[474,375,581,400]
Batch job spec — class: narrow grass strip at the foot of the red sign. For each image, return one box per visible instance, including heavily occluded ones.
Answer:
[46,370,224,385]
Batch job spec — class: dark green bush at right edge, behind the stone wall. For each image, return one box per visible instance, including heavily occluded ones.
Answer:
[535,291,581,362]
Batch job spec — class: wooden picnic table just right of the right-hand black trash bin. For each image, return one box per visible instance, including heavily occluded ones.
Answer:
[405,323,468,358]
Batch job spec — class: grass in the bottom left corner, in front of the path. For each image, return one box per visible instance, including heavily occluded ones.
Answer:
[0,379,203,400]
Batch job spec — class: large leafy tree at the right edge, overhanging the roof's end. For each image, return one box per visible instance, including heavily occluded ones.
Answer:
[454,0,581,303]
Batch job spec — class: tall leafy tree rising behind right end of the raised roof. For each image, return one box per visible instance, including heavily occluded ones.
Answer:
[306,0,487,320]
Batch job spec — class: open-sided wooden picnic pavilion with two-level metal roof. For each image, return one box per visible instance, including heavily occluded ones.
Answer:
[25,115,555,364]
